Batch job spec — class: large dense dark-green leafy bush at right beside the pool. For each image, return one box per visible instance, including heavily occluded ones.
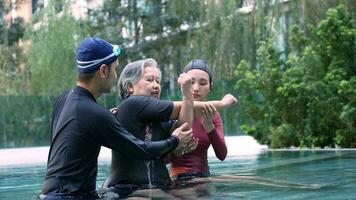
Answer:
[235,6,356,148]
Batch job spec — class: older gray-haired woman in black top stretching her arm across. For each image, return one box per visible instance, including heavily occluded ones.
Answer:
[104,59,236,196]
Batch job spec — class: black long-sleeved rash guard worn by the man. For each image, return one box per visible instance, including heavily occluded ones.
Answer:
[41,86,179,195]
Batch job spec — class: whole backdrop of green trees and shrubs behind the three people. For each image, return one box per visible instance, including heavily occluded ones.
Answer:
[0,0,356,148]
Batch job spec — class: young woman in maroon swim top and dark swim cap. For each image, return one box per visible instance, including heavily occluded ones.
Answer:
[170,59,227,181]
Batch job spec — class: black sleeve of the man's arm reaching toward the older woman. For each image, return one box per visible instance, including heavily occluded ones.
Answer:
[90,112,179,160]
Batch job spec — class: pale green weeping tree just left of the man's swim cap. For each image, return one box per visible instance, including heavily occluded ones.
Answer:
[27,0,81,95]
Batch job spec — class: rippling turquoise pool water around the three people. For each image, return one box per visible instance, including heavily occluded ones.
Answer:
[0,150,356,200]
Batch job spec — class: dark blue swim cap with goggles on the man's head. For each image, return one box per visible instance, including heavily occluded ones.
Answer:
[76,37,121,73]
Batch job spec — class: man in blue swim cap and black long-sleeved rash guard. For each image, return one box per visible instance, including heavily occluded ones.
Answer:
[40,38,194,199]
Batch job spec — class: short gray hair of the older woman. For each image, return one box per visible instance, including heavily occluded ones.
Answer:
[117,58,161,99]
